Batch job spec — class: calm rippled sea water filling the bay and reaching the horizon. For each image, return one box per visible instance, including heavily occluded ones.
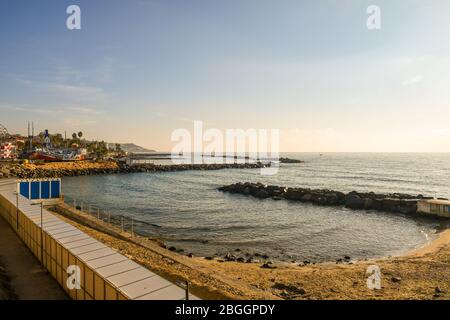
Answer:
[63,153,450,261]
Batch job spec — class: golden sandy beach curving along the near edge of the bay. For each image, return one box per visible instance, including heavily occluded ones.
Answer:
[49,204,450,300]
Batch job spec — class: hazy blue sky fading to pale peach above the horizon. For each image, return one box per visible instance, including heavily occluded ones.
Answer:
[0,0,450,152]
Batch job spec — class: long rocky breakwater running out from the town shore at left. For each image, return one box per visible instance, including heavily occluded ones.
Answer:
[0,162,268,179]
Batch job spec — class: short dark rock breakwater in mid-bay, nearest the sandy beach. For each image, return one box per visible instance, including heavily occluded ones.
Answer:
[218,182,442,214]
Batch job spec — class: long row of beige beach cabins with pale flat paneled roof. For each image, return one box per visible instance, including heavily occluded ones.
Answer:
[0,179,198,300]
